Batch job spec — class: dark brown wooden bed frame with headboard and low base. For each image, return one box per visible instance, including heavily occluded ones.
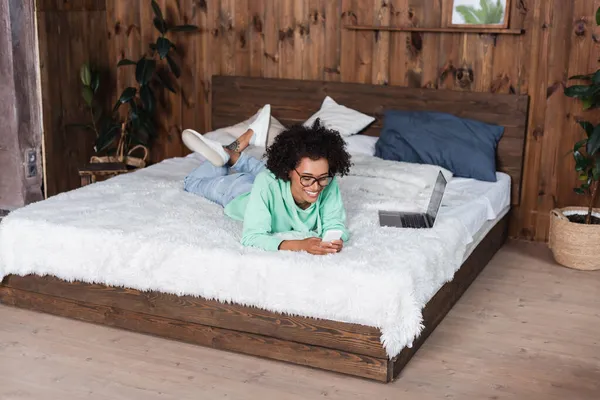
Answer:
[0,77,528,382]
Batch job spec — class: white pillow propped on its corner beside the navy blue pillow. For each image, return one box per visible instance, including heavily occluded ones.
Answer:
[304,96,375,136]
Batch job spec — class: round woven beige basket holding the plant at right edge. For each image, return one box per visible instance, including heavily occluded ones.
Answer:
[548,207,600,271]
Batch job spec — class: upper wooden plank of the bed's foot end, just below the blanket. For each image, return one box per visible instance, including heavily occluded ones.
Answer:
[3,275,386,358]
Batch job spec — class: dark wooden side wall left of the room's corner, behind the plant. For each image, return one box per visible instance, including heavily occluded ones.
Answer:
[37,0,109,196]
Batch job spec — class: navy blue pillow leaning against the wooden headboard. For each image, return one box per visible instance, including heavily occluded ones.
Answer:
[375,110,504,182]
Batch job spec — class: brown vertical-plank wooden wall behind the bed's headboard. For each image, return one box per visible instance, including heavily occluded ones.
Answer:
[38,0,600,240]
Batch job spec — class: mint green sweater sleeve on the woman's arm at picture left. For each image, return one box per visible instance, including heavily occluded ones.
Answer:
[242,179,283,251]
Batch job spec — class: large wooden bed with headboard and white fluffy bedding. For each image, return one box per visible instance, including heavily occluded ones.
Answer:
[0,76,528,382]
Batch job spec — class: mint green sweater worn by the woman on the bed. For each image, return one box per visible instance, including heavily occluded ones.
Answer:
[225,170,349,251]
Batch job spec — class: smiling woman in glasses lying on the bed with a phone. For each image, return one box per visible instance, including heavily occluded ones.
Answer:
[183,105,350,255]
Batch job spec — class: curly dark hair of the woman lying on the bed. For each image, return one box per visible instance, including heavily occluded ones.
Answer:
[267,119,351,181]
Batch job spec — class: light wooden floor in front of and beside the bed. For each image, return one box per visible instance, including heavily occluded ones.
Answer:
[0,242,600,400]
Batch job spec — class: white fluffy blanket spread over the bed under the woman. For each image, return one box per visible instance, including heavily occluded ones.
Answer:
[0,152,470,357]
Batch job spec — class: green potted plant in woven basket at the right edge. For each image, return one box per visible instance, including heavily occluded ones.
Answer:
[549,8,600,270]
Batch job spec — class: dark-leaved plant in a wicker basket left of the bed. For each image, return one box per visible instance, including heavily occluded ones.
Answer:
[80,0,198,168]
